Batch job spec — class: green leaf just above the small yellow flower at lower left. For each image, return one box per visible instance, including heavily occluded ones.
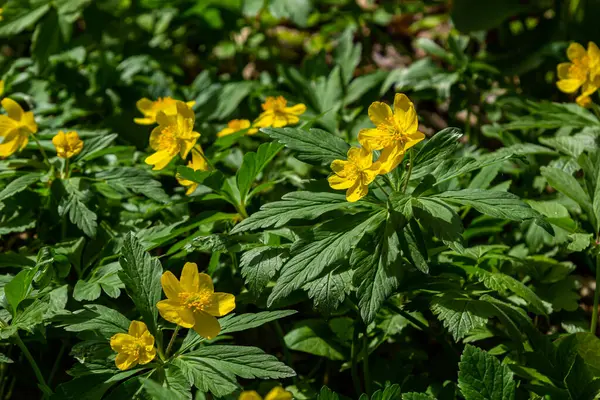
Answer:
[59,304,131,339]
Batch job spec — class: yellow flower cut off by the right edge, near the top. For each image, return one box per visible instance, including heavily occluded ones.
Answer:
[556,42,600,107]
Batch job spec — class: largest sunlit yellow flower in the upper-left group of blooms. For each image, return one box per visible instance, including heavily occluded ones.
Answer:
[146,101,200,170]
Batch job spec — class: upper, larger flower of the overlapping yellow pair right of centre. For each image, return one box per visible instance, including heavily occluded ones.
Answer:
[358,93,425,174]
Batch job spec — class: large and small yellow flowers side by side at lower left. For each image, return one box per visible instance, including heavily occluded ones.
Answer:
[110,263,235,370]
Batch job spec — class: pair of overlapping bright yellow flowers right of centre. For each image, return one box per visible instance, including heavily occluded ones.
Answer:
[328,93,425,202]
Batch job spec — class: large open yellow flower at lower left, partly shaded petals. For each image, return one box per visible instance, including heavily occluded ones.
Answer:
[156,263,235,339]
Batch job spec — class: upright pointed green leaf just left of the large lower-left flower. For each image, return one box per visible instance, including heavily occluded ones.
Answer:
[119,233,162,335]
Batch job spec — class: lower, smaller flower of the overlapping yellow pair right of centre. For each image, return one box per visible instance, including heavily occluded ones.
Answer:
[327,147,381,202]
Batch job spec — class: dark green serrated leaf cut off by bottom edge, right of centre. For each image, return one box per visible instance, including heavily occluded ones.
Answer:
[458,345,516,400]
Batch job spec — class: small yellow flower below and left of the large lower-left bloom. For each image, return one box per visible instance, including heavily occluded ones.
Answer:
[110,321,156,371]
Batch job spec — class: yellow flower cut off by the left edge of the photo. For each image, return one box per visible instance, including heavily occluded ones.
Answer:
[0,98,37,157]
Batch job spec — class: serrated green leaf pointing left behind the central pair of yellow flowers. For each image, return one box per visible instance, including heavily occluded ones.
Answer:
[261,128,350,165]
